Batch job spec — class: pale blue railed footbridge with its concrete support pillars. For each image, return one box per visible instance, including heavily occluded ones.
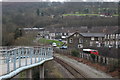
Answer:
[0,46,53,80]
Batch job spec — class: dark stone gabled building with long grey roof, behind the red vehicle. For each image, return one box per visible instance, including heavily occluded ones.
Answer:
[67,32,104,49]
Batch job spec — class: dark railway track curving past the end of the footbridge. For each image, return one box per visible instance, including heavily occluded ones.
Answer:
[54,56,87,80]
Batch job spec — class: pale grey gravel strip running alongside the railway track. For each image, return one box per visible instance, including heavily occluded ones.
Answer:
[54,54,112,78]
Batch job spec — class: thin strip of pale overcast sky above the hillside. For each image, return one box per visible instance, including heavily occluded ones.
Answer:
[0,0,120,2]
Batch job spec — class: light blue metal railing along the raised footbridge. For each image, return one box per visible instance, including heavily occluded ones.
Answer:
[0,47,53,76]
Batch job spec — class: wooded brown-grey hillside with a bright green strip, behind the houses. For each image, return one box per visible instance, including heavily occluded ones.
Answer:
[2,2,118,45]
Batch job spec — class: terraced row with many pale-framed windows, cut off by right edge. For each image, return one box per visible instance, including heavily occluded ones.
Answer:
[104,30,120,48]
